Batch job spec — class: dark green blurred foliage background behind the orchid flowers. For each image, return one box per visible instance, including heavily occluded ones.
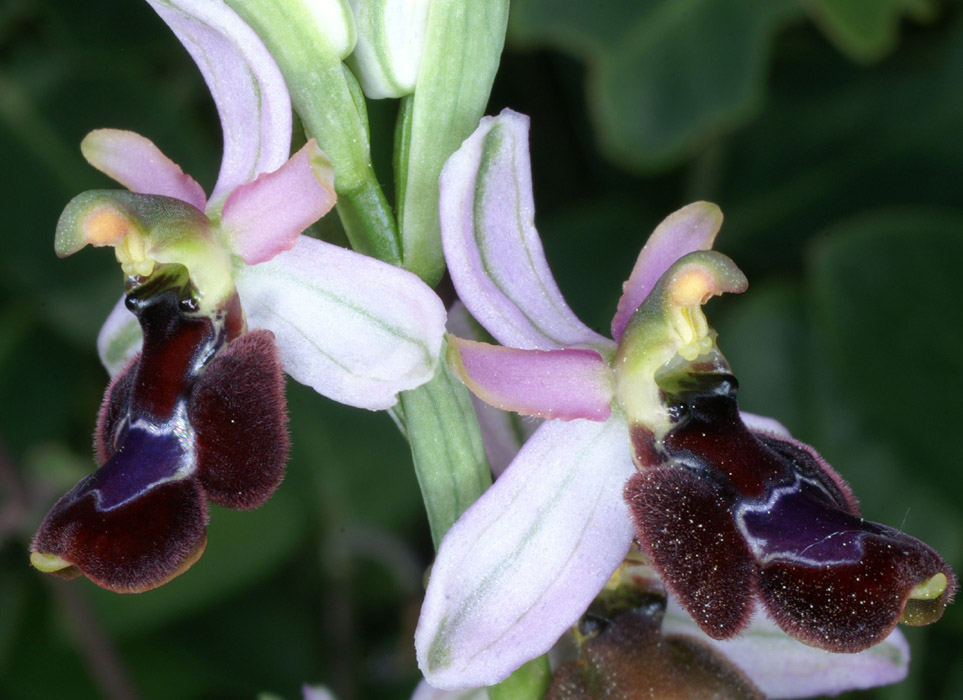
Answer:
[0,0,963,700]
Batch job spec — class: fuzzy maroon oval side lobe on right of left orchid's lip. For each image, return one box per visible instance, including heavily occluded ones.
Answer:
[188,330,289,508]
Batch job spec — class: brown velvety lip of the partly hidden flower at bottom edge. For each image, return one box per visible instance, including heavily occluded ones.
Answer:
[545,603,764,700]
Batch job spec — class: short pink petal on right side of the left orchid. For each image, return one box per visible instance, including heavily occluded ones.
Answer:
[221,139,336,265]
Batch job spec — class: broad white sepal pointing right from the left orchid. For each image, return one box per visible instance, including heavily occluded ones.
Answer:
[236,236,445,410]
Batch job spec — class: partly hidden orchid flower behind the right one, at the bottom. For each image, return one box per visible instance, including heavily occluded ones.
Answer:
[434,302,909,700]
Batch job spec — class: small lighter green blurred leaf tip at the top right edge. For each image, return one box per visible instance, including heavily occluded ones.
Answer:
[809,0,936,62]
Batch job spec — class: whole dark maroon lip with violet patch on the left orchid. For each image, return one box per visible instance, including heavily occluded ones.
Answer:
[31,265,288,592]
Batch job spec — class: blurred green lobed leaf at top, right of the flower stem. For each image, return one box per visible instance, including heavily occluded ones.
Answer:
[509,0,799,170]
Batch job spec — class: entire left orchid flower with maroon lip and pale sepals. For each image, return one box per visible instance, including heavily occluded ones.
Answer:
[31,0,445,592]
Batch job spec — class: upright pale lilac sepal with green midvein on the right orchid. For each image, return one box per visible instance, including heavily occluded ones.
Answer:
[439,110,614,352]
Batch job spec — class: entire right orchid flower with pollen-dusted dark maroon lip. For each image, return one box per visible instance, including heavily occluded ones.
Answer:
[415,111,956,688]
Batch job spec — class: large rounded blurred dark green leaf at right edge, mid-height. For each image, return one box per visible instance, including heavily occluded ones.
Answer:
[812,210,963,478]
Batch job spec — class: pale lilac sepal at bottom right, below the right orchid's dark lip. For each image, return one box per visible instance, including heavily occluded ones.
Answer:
[662,596,910,699]
